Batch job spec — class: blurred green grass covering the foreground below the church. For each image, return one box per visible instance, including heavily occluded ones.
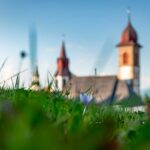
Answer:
[0,89,150,150]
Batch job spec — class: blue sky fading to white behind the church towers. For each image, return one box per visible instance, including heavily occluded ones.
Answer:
[0,0,150,89]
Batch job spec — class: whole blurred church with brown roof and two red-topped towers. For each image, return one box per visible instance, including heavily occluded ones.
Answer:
[54,15,141,103]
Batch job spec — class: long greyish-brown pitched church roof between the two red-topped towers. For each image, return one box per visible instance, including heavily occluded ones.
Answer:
[67,76,133,103]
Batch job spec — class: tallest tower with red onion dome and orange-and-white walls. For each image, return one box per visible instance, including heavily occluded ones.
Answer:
[117,12,141,94]
